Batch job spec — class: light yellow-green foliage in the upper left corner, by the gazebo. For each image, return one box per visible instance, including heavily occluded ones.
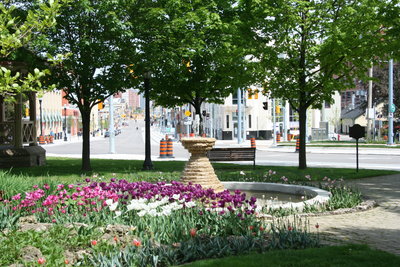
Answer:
[0,0,62,99]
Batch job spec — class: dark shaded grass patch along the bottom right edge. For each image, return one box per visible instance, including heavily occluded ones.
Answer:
[182,245,400,267]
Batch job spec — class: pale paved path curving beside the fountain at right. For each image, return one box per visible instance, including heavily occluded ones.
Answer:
[309,174,400,255]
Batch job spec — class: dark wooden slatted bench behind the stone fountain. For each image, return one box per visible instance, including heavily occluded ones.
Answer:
[207,147,256,168]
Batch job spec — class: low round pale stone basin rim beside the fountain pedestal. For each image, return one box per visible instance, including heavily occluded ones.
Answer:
[222,182,331,211]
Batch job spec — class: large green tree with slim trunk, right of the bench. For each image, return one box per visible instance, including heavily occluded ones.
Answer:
[239,0,387,169]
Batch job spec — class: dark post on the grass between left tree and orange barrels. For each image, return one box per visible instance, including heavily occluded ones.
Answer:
[143,71,153,170]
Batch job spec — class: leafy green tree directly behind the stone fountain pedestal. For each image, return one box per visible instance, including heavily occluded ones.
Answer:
[123,0,252,133]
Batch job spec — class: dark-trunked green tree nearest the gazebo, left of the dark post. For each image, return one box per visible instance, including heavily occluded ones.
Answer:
[45,0,133,171]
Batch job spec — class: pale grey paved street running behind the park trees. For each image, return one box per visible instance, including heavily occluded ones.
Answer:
[44,121,400,170]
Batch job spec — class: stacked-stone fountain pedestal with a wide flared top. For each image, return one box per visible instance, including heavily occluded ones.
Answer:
[181,137,224,192]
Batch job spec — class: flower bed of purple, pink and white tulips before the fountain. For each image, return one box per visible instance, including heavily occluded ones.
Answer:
[0,179,318,266]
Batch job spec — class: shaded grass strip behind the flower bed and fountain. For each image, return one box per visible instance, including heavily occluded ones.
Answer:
[0,158,398,197]
